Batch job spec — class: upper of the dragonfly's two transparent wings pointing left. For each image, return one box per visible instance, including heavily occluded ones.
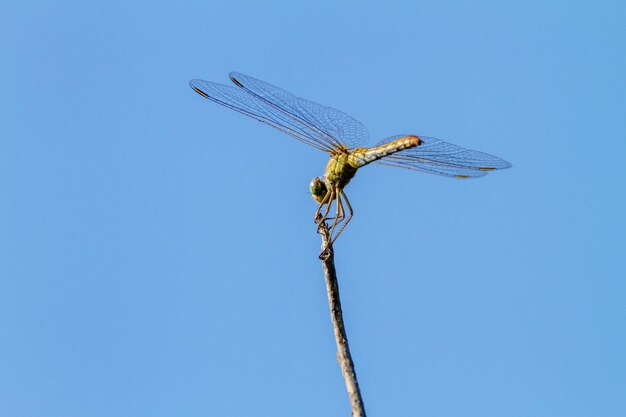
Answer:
[229,72,369,149]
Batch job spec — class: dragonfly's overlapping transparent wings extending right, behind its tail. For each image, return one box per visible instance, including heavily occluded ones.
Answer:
[375,135,511,178]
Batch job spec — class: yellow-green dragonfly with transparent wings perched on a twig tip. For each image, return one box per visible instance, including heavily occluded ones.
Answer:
[189,72,511,257]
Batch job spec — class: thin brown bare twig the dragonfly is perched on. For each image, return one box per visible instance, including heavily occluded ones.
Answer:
[318,222,365,417]
